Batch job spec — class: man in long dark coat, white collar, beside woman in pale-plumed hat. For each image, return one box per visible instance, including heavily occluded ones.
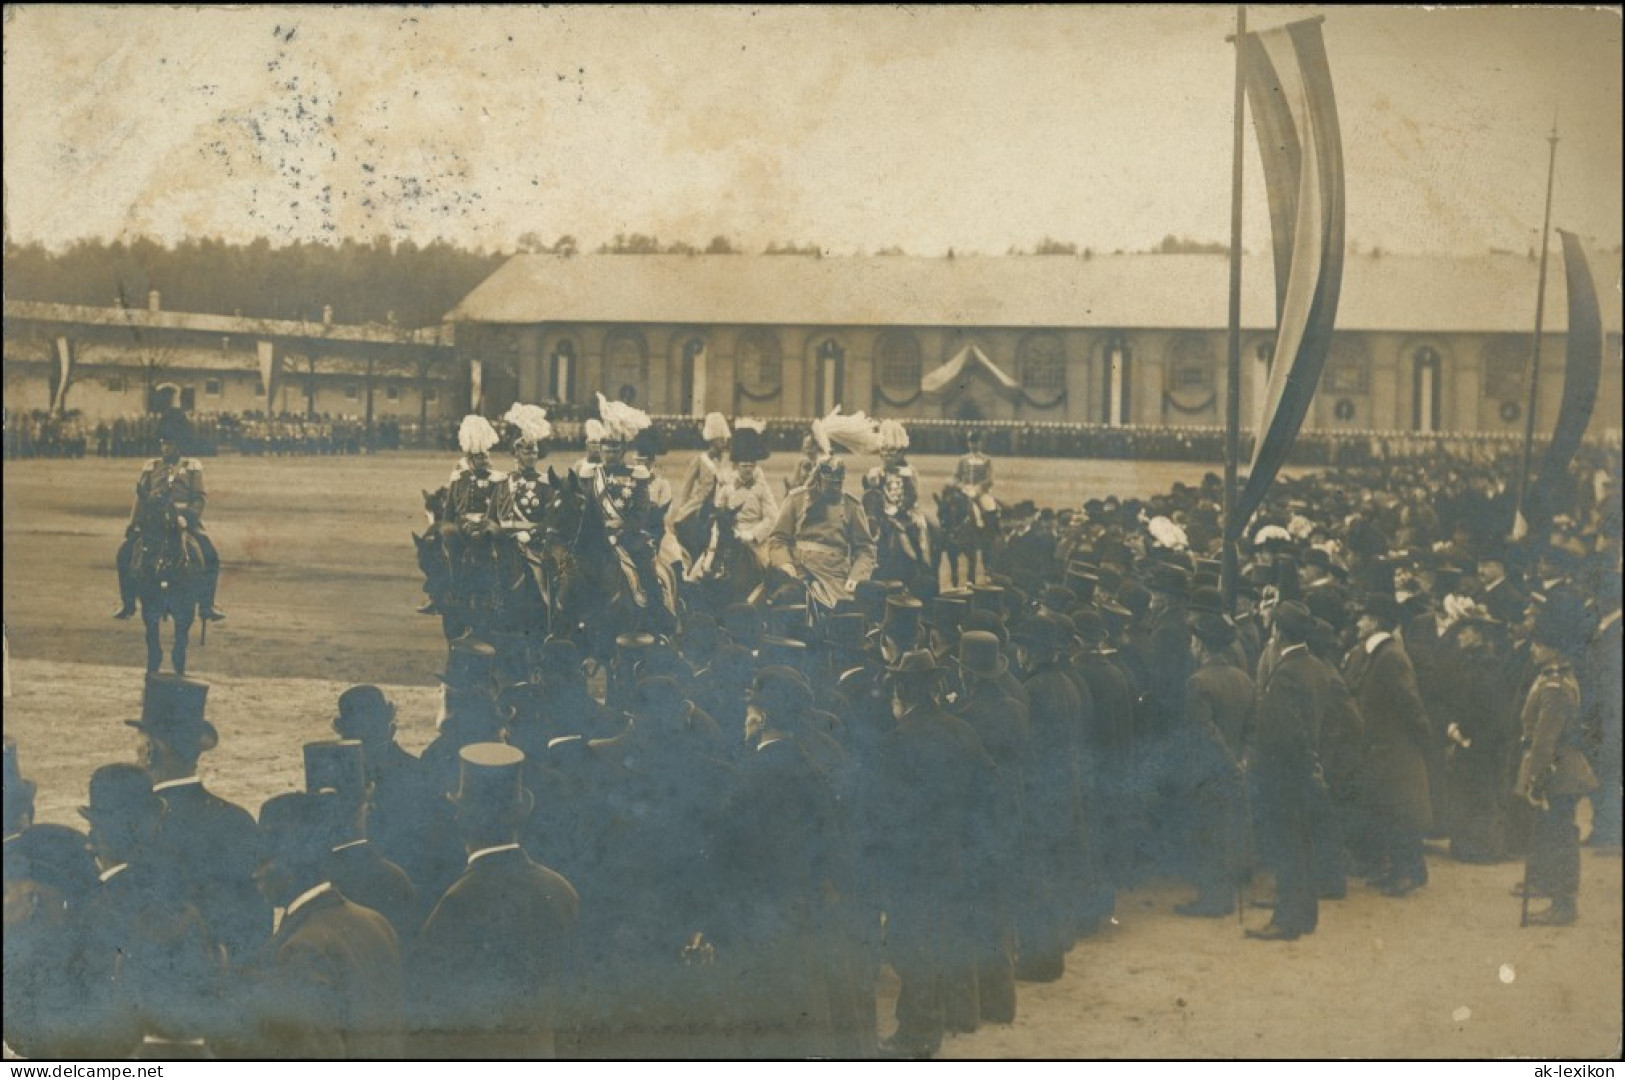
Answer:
[1344,591,1433,896]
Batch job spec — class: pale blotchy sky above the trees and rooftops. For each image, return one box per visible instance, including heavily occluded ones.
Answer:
[5,6,1625,255]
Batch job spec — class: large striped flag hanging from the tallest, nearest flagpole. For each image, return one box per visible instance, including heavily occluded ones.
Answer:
[1230,19,1344,539]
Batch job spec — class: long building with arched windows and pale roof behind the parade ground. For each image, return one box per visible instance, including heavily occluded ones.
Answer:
[449,255,1622,432]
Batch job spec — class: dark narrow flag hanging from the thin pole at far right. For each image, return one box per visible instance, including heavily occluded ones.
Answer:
[1523,229,1602,529]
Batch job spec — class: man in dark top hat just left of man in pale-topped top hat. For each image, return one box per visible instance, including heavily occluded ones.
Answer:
[304,739,423,940]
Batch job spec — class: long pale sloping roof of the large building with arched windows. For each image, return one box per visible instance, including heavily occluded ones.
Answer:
[447,253,1620,333]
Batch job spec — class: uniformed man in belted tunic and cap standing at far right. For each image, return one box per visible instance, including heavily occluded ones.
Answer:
[1515,590,1597,926]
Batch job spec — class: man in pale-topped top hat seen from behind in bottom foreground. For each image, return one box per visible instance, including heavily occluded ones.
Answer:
[408,742,580,1059]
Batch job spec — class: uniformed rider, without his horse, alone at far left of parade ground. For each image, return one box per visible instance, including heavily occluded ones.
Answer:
[112,408,226,620]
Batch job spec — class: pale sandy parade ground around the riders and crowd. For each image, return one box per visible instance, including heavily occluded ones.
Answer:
[3,453,1622,1059]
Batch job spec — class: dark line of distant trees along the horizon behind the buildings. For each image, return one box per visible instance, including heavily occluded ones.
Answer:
[5,232,1227,328]
